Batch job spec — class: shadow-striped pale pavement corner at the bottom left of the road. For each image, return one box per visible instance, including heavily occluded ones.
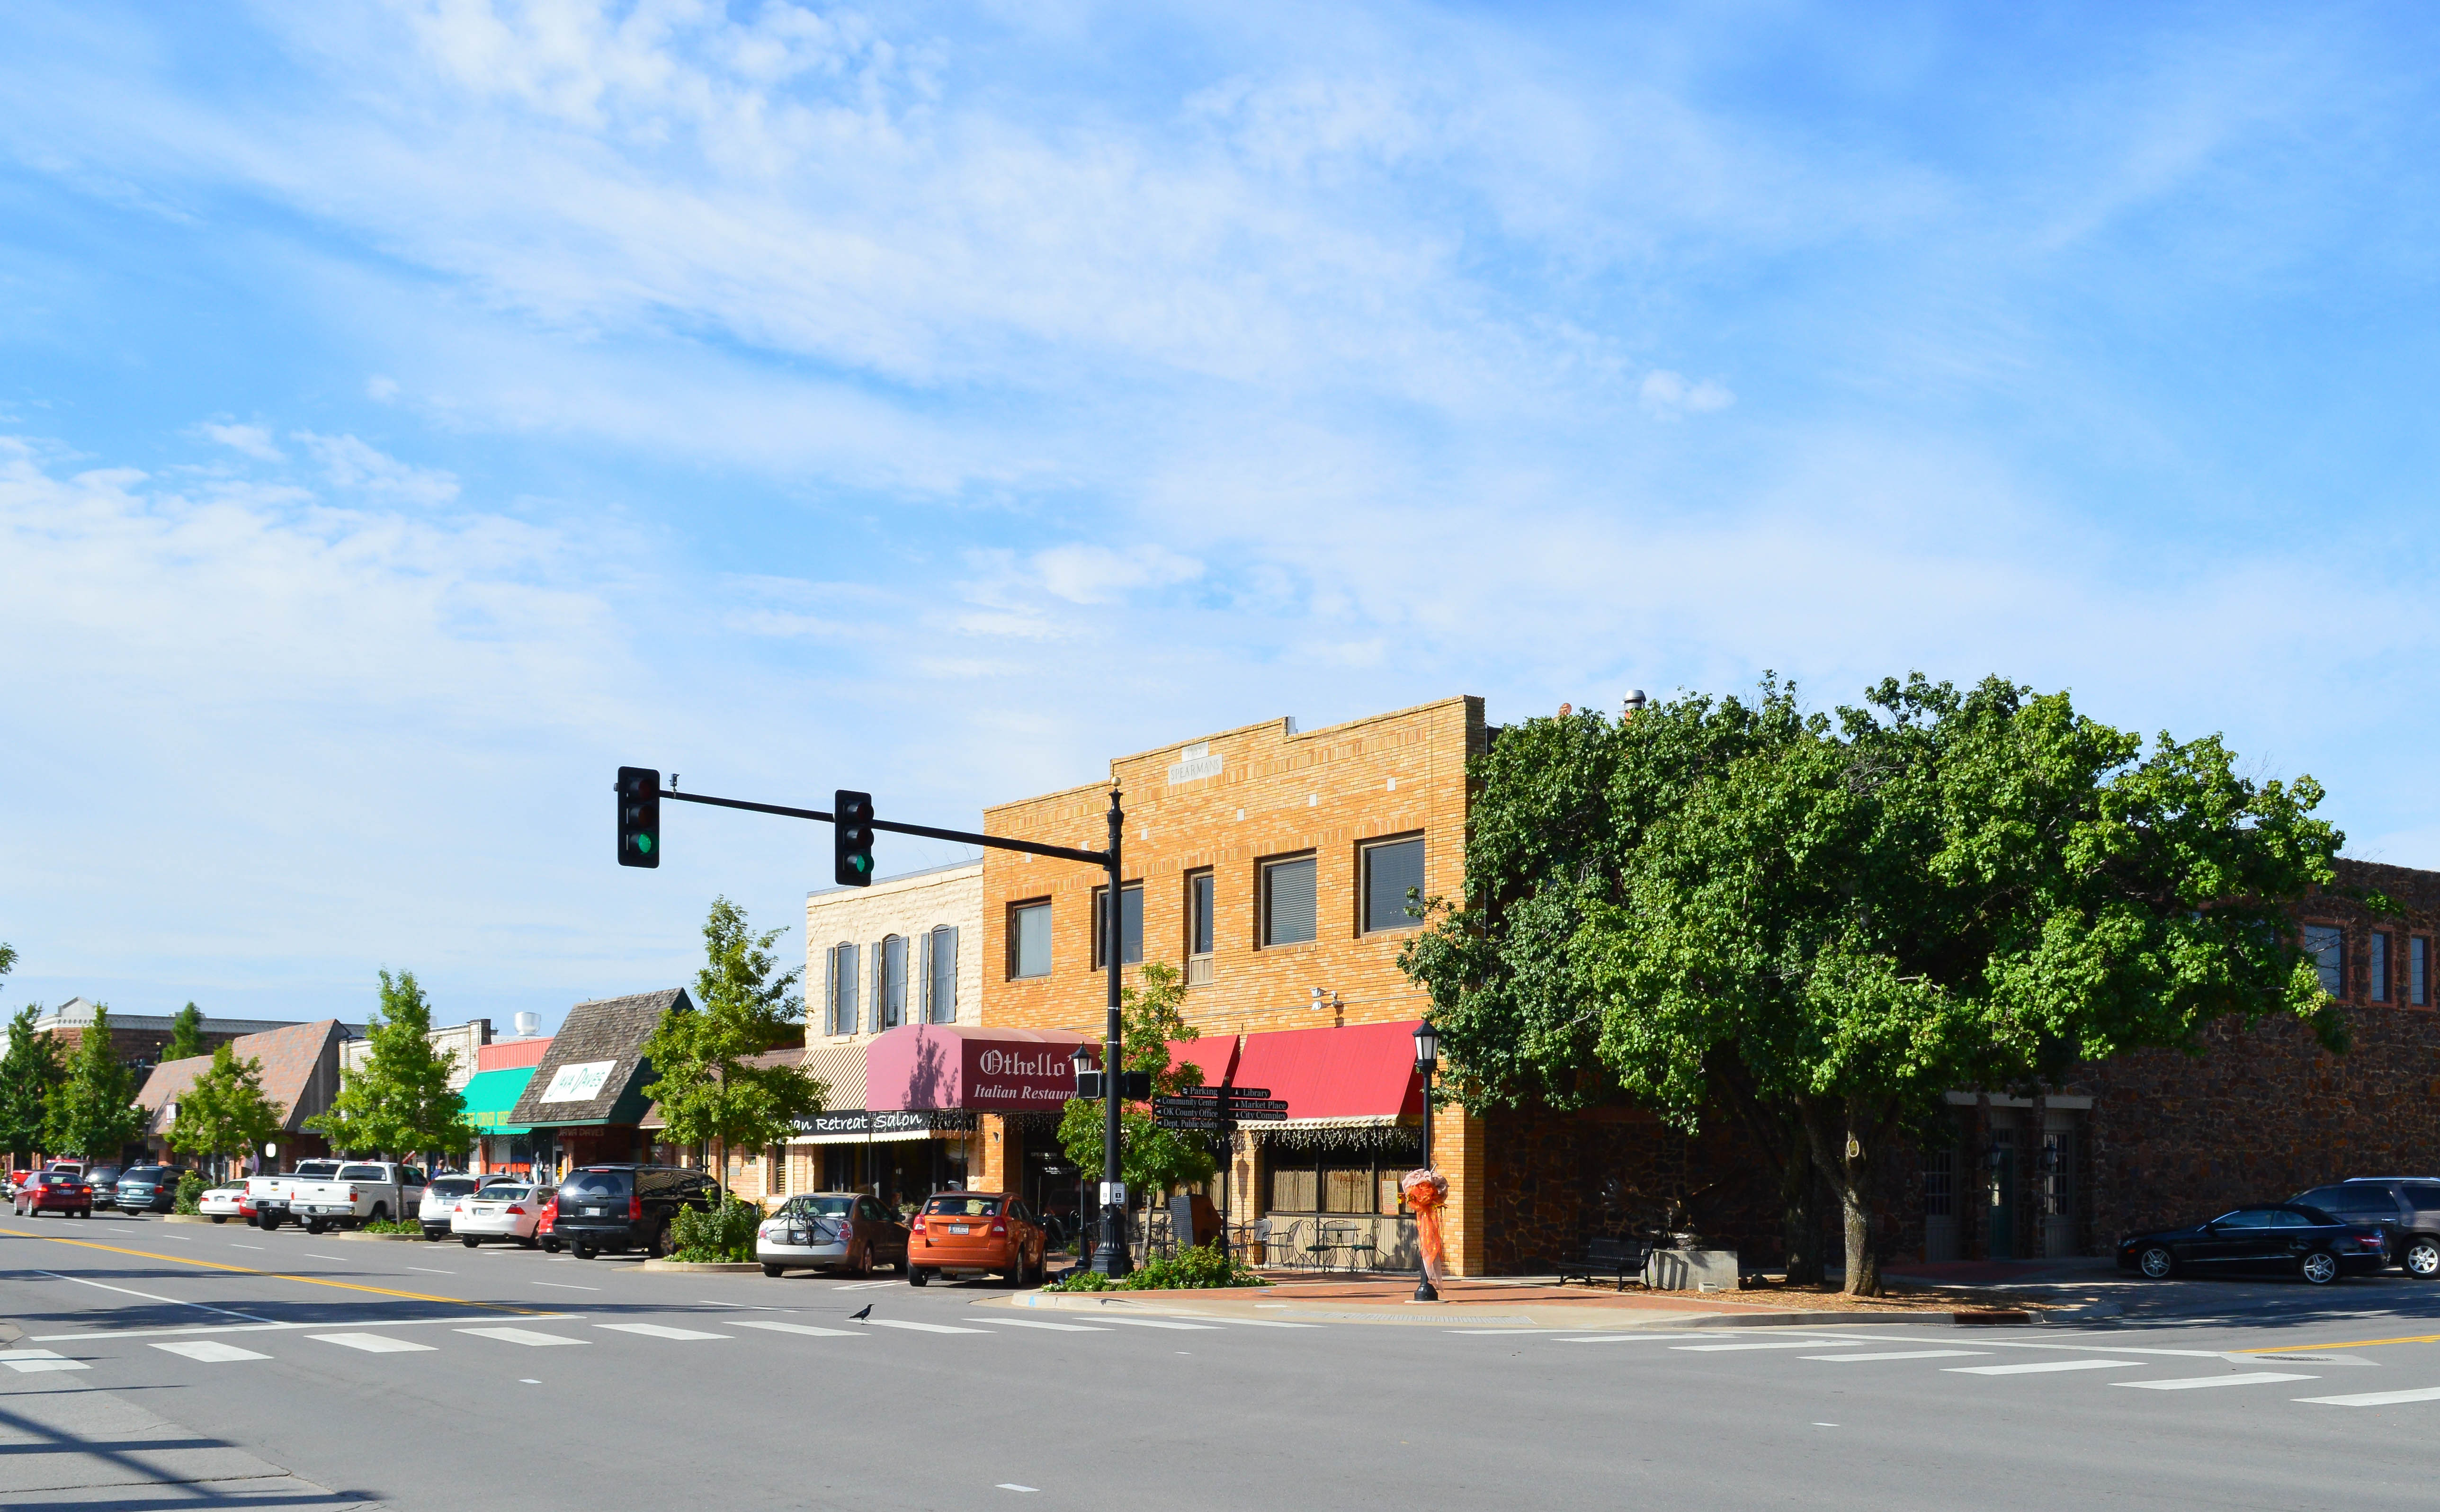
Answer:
[0,1376,378,1512]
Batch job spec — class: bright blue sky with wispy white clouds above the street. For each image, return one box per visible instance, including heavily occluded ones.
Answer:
[0,0,2440,1027]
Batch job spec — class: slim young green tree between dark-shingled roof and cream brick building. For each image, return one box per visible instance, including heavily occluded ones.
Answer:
[644,897,830,1165]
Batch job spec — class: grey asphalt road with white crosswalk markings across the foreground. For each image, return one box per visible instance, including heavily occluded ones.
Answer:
[0,1215,2440,1512]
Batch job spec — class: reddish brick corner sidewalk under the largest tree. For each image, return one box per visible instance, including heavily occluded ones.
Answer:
[976,1275,2032,1332]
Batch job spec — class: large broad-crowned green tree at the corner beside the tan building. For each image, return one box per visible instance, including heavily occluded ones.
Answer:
[1410,676,2342,1295]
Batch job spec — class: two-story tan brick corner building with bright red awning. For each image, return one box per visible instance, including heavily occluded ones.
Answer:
[976,698,1488,1273]
